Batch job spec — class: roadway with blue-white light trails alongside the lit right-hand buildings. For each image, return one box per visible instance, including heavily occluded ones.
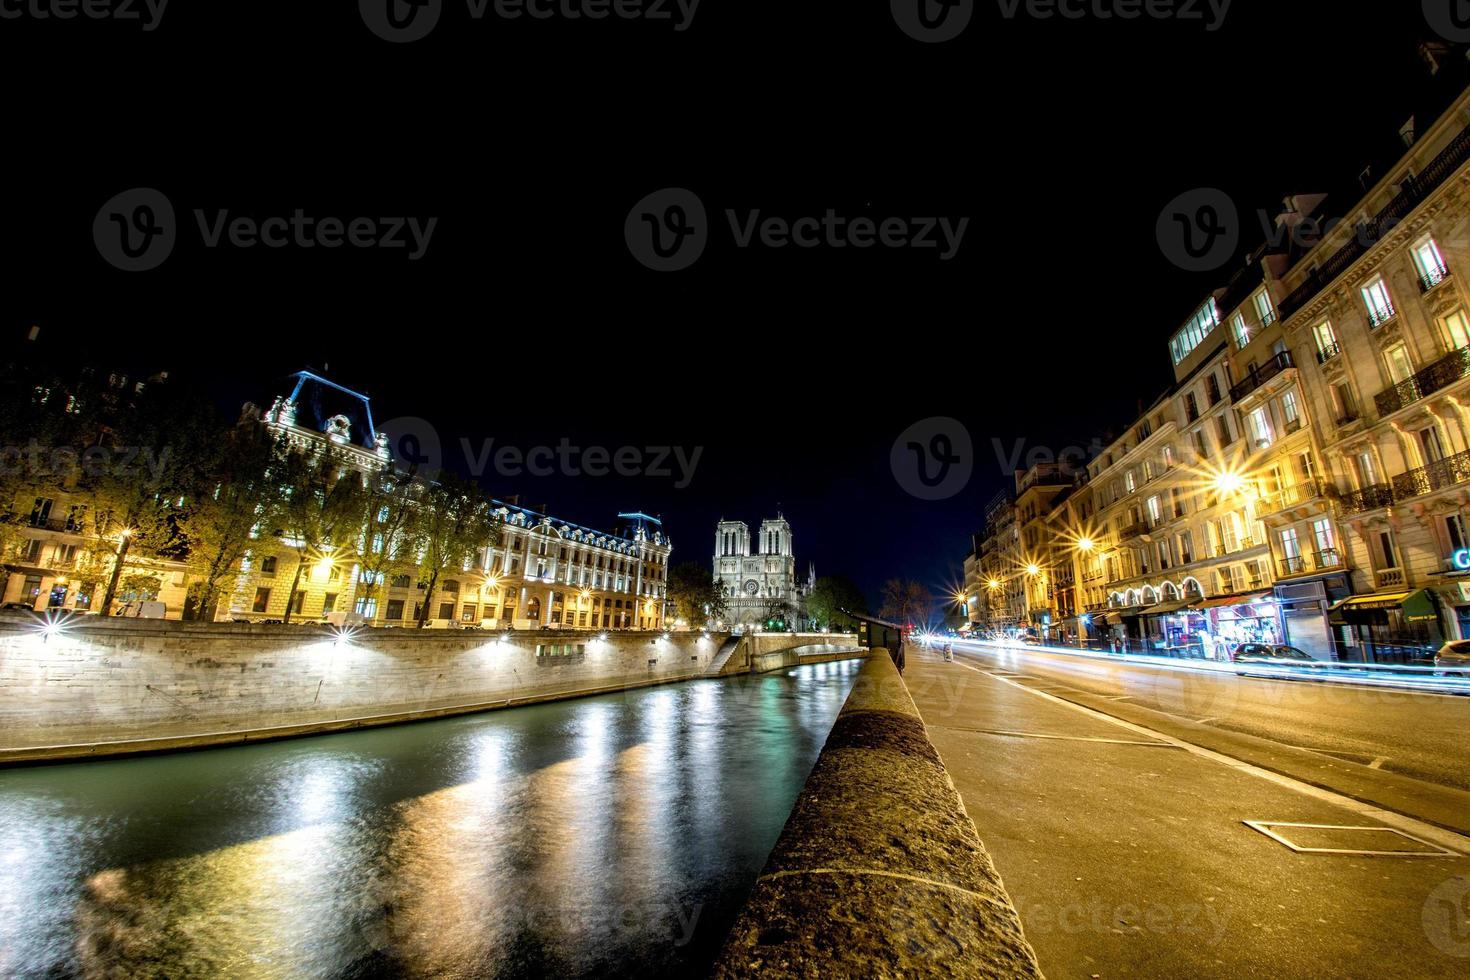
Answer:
[958,644,1470,789]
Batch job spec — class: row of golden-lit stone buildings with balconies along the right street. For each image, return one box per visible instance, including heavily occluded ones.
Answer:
[966,57,1470,663]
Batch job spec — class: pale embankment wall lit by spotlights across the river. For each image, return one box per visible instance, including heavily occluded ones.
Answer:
[0,613,850,763]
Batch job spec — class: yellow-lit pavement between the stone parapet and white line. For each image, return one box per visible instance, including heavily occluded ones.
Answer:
[906,649,1470,980]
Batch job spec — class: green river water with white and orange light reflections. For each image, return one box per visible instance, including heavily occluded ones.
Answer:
[0,661,858,979]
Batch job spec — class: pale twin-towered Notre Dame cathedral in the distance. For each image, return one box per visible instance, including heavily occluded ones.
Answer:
[714,514,816,627]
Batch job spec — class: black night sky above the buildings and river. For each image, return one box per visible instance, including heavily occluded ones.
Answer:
[0,0,1448,608]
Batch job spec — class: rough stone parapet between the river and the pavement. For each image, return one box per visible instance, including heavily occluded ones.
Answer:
[714,651,1041,980]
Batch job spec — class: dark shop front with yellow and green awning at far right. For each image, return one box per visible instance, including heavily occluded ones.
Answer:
[1327,589,1444,664]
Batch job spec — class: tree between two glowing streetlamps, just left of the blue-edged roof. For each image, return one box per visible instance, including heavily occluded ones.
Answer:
[175,425,282,623]
